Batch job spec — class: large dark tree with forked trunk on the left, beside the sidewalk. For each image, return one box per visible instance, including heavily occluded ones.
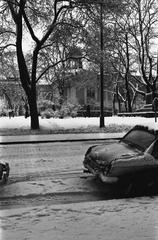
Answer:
[0,0,74,129]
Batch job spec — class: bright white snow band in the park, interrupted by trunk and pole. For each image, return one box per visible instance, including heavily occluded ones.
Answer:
[0,116,158,130]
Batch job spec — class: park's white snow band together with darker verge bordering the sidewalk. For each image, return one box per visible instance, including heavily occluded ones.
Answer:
[0,116,158,135]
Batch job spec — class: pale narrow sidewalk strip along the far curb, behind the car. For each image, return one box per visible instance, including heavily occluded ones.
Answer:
[0,133,125,145]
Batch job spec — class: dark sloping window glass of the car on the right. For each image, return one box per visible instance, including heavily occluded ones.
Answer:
[122,130,155,150]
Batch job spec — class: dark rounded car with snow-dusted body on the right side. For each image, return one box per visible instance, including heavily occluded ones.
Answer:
[83,126,158,192]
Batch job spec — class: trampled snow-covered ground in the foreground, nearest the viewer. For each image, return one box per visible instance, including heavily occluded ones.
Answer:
[0,197,158,240]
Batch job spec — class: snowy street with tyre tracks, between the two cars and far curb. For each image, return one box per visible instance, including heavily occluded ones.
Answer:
[0,140,119,209]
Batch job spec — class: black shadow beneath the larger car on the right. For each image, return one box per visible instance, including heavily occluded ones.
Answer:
[89,172,158,200]
